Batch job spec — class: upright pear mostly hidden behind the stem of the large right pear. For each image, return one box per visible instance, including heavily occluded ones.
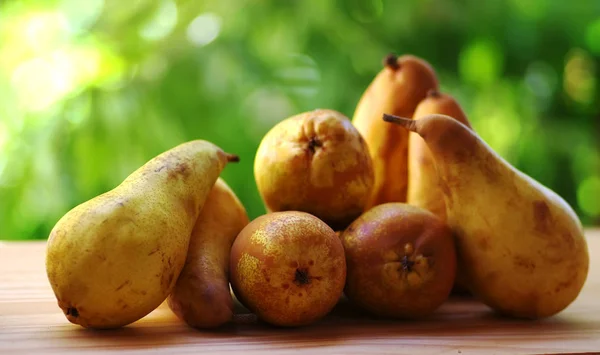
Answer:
[407,90,472,220]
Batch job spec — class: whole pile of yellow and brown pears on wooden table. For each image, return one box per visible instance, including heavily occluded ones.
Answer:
[46,55,589,328]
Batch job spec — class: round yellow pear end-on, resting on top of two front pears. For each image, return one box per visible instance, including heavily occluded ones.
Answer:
[254,109,374,230]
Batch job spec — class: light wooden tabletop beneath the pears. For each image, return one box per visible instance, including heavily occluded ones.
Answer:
[0,229,600,355]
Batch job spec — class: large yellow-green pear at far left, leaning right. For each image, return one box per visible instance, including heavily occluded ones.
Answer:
[46,140,237,328]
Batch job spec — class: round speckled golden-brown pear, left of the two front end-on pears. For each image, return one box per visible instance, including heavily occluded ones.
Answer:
[230,211,346,327]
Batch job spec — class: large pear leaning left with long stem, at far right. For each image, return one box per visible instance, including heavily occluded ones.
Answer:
[384,114,589,319]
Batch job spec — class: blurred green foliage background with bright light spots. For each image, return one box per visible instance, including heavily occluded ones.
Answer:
[0,0,600,239]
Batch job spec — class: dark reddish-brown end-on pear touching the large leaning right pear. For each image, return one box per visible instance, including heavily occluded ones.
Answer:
[341,202,456,319]
